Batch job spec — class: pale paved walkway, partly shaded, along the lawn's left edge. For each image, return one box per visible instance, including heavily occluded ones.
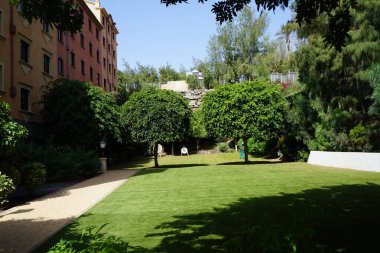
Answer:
[0,170,138,253]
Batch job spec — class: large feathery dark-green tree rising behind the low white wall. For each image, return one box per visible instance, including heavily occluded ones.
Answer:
[294,0,380,151]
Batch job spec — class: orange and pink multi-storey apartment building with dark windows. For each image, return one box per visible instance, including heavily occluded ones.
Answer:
[0,0,118,136]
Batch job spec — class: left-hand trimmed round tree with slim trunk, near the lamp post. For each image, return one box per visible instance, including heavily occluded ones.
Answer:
[122,87,191,168]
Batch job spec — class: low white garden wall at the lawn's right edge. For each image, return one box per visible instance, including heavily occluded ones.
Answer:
[307,151,380,172]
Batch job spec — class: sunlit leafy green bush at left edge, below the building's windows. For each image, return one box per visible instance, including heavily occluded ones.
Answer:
[0,101,28,156]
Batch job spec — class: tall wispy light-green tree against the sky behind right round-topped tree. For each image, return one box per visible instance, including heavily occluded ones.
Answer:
[208,7,269,83]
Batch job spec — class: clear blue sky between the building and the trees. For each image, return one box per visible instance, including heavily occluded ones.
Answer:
[101,0,290,70]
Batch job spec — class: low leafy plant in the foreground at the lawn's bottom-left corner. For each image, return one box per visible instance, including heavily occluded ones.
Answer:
[48,225,132,253]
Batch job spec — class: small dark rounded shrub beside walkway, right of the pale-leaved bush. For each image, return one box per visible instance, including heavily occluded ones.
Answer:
[22,162,46,194]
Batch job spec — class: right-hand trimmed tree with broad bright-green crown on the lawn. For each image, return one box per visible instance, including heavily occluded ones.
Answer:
[201,80,287,163]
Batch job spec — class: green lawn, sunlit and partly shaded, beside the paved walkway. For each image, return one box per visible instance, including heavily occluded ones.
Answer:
[40,153,380,253]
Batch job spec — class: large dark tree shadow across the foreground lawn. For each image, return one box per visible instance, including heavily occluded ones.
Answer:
[146,184,380,253]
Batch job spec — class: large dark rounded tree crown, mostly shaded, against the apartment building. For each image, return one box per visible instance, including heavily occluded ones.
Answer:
[42,79,121,150]
